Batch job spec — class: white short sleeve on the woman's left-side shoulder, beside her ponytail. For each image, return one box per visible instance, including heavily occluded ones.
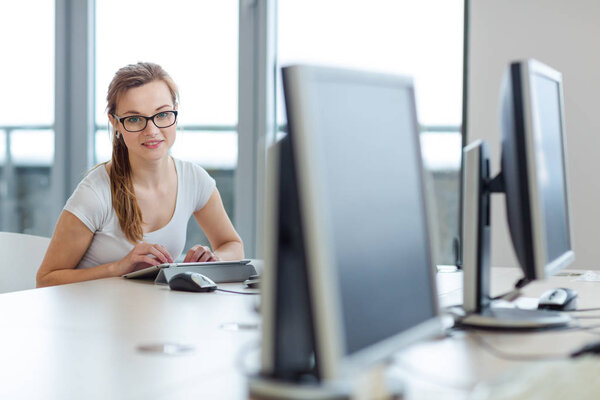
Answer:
[64,171,110,232]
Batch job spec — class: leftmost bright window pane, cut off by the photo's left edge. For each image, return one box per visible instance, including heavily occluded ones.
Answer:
[0,0,56,236]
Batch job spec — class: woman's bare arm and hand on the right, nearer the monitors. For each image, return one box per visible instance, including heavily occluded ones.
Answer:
[184,188,244,262]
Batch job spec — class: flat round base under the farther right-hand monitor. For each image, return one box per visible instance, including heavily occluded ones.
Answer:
[459,307,571,330]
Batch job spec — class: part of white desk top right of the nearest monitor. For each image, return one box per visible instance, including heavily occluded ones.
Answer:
[393,268,600,400]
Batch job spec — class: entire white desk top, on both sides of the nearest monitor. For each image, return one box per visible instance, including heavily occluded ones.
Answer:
[0,268,600,399]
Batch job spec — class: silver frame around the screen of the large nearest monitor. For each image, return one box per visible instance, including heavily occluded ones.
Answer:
[284,66,442,380]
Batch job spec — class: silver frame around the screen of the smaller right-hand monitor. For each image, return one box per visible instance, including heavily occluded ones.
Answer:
[518,59,575,279]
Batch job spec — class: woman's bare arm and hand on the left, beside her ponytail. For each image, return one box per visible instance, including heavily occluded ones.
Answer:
[36,211,173,287]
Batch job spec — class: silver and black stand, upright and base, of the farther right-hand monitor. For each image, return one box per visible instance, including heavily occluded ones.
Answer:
[459,140,571,330]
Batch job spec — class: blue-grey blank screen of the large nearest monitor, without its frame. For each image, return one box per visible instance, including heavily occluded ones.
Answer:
[310,77,435,353]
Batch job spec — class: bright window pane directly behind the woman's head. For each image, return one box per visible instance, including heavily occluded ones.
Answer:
[95,0,238,255]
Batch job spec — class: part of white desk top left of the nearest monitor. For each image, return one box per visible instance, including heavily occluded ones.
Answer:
[0,278,259,399]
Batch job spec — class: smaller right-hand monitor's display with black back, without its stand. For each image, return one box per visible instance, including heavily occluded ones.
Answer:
[502,60,574,280]
